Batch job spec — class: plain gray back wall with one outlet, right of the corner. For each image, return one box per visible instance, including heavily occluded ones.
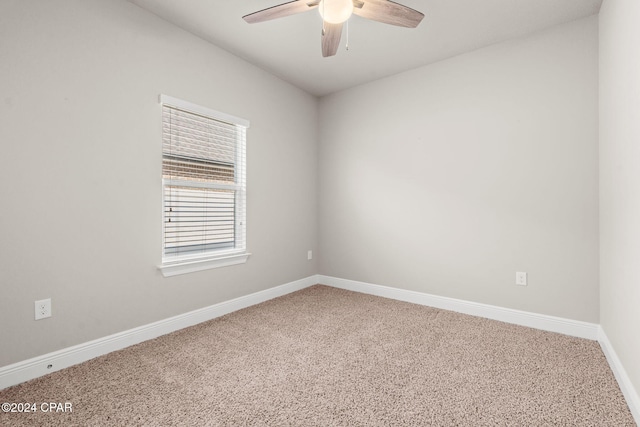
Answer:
[319,16,599,323]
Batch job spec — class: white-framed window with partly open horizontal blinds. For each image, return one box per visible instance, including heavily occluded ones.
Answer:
[160,95,249,276]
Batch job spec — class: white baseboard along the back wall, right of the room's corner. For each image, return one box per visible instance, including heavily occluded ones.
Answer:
[318,275,599,341]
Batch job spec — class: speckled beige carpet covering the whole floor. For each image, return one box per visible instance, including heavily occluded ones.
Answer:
[0,286,635,426]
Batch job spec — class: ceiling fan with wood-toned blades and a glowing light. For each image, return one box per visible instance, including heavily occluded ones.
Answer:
[242,0,424,57]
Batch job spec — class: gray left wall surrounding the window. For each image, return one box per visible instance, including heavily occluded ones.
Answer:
[0,0,317,366]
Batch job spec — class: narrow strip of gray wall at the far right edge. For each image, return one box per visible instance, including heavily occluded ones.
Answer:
[600,0,640,404]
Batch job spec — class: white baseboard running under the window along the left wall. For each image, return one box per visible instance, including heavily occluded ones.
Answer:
[0,276,318,390]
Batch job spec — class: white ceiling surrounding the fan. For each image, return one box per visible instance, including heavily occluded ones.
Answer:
[130,0,602,96]
